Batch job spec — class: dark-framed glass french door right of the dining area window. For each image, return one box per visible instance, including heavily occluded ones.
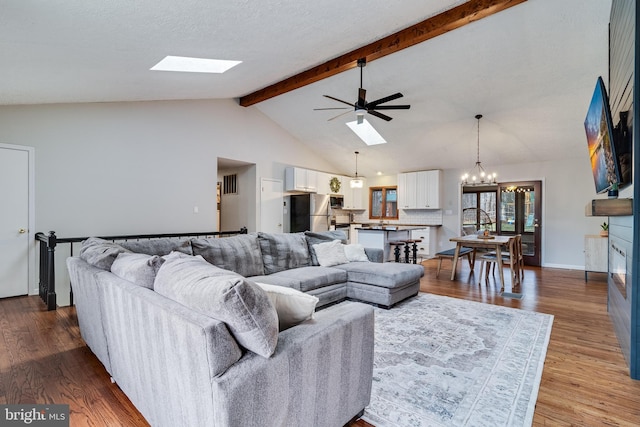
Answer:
[497,181,542,266]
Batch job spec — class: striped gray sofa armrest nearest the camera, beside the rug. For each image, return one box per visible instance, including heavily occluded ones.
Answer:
[214,302,374,426]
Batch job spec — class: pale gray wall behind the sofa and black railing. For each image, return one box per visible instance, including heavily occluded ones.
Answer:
[0,100,332,305]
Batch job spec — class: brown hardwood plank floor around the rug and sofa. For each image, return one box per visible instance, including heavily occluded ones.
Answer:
[0,260,640,427]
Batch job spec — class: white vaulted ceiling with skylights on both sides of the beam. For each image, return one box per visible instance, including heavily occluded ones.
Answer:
[0,0,611,175]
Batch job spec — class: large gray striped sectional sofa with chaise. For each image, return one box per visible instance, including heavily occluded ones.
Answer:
[67,232,424,426]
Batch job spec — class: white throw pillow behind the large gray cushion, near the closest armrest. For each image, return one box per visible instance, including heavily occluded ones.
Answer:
[256,282,320,331]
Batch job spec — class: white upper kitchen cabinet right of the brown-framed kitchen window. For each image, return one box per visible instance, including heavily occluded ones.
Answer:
[398,170,442,209]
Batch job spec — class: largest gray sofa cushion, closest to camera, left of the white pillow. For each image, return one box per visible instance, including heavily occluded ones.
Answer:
[154,253,278,357]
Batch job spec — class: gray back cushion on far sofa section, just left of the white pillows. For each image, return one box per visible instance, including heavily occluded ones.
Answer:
[258,232,311,274]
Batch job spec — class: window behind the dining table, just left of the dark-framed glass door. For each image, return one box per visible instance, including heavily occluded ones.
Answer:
[462,187,498,232]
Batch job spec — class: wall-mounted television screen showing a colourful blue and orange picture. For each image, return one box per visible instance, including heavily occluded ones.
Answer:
[584,77,620,193]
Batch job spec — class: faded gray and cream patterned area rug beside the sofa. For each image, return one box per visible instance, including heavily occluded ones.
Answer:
[362,293,553,427]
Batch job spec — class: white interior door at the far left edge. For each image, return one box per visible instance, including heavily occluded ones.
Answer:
[0,147,31,298]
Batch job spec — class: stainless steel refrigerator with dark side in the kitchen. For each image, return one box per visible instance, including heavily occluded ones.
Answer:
[289,194,331,233]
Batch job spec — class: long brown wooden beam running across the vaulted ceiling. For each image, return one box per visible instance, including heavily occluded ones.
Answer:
[239,0,527,107]
